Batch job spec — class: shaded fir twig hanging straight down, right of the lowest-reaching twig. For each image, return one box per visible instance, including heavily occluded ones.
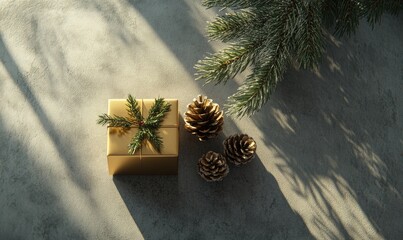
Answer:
[295,2,324,69]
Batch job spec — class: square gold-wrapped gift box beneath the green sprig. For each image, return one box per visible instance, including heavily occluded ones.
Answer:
[107,99,179,175]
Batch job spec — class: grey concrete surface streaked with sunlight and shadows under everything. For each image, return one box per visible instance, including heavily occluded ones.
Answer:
[0,0,403,240]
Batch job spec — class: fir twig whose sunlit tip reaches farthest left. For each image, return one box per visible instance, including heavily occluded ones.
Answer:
[195,0,298,87]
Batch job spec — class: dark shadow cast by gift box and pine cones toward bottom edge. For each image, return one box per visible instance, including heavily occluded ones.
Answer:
[113,115,311,239]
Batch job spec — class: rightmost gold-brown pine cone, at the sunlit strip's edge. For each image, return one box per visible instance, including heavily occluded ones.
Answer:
[224,134,256,165]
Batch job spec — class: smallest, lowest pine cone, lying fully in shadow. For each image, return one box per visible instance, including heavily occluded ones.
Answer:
[198,151,229,182]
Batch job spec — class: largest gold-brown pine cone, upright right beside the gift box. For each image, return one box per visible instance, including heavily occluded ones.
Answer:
[185,95,224,141]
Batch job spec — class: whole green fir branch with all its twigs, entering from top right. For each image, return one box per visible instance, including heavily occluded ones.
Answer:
[195,0,403,116]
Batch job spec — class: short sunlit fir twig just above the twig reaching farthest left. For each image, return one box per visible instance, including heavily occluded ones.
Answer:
[207,10,257,42]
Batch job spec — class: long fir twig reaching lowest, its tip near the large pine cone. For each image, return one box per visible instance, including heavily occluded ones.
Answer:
[225,0,301,117]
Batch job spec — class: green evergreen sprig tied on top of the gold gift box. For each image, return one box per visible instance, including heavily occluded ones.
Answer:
[97,94,171,154]
